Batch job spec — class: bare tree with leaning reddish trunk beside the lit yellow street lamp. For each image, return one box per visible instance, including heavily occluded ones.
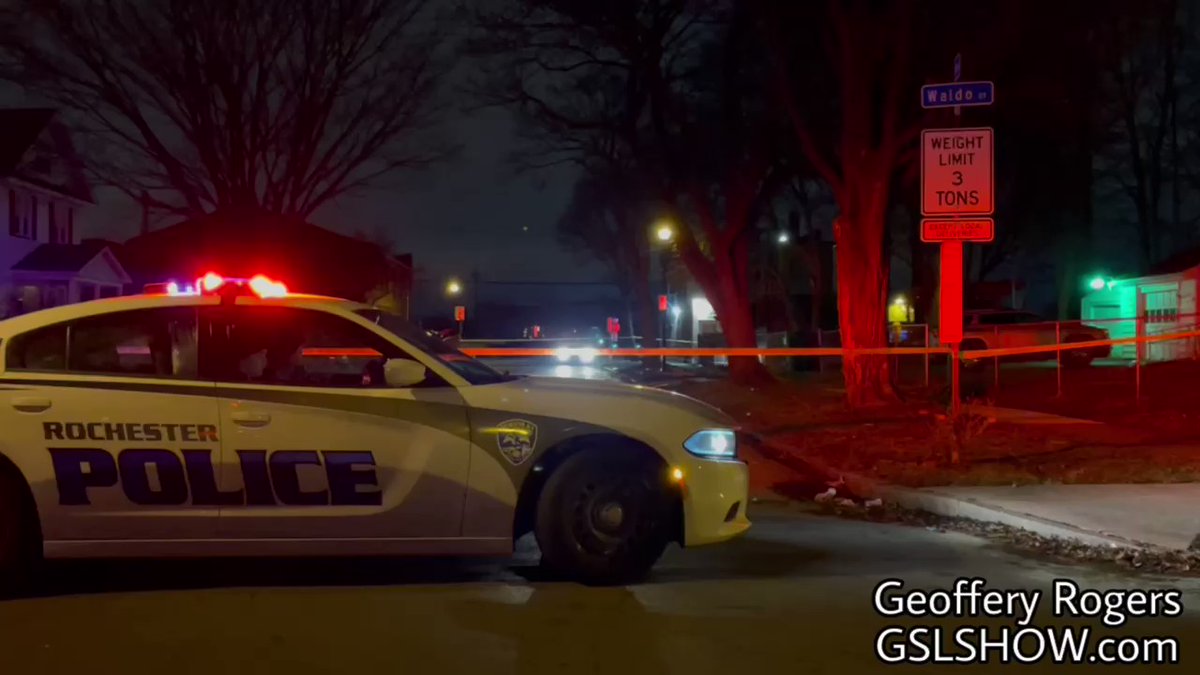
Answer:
[463,0,786,382]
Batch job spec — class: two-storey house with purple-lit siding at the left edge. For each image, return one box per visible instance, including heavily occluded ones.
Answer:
[0,108,130,318]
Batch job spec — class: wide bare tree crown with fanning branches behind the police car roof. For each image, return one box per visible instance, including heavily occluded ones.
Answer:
[0,0,444,217]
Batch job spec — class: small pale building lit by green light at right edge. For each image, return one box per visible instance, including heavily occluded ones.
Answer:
[1080,249,1200,362]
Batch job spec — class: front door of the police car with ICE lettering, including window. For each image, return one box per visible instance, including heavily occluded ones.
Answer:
[202,304,469,539]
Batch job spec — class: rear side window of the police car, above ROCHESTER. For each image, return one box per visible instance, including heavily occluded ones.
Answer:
[7,307,197,378]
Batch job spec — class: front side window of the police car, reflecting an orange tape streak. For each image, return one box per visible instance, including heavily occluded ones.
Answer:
[202,306,420,388]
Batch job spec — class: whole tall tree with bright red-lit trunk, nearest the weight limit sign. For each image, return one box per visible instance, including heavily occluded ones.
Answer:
[760,0,918,405]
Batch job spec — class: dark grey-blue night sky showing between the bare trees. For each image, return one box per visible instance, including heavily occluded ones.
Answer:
[0,79,611,310]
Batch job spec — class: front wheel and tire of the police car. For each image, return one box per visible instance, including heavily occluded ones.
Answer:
[534,448,674,585]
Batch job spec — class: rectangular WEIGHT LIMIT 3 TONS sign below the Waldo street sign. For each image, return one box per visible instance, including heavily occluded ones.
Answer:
[920,129,995,216]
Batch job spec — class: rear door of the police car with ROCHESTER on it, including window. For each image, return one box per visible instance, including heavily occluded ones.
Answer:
[0,306,220,542]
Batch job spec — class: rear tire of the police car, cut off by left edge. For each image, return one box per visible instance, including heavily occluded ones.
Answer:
[0,468,42,597]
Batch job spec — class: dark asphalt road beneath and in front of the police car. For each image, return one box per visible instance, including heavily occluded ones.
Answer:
[0,507,1200,675]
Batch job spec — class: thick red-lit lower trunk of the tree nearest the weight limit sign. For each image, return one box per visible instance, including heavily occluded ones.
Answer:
[834,204,896,406]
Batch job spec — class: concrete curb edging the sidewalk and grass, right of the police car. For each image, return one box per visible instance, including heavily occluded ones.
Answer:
[760,438,1156,551]
